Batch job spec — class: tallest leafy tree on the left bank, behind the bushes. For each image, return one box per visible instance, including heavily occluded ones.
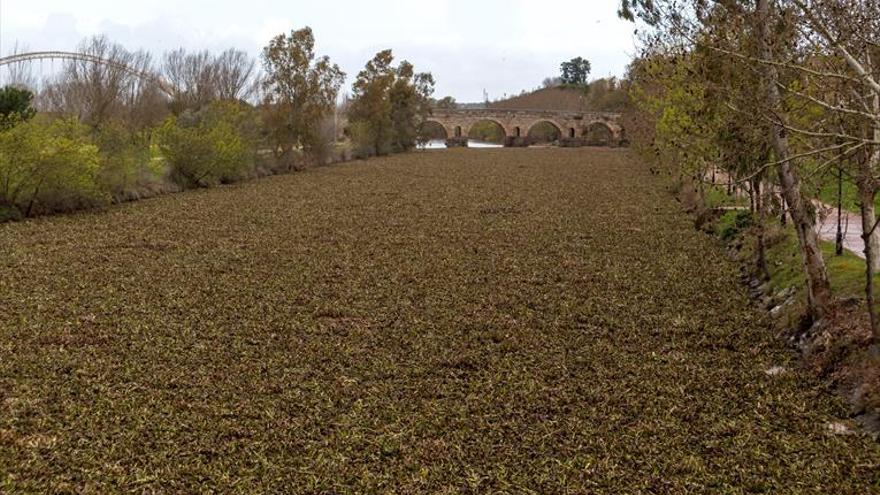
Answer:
[263,27,345,169]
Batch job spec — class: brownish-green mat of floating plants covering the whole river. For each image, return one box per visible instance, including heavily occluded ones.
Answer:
[0,149,880,494]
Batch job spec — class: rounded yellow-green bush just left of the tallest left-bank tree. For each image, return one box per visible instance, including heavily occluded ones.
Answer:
[157,104,256,188]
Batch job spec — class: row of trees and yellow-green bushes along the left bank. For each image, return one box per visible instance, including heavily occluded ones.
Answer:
[0,27,434,221]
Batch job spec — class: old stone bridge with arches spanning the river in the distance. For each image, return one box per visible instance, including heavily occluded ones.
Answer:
[425,108,627,146]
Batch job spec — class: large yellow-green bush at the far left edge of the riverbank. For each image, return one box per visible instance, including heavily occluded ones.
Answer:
[0,120,107,219]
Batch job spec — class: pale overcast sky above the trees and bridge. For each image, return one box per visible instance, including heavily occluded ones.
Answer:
[0,0,634,101]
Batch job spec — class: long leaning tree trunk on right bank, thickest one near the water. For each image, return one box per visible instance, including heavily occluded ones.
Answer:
[756,0,831,321]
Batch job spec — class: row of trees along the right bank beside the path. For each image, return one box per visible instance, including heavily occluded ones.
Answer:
[620,0,880,342]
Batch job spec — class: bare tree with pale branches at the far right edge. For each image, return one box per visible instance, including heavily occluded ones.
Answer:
[791,0,880,340]
